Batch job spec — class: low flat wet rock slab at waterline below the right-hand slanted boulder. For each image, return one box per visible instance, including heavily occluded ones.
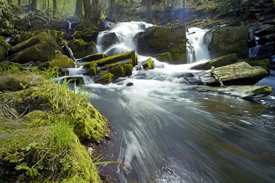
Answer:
[193,85,273,99]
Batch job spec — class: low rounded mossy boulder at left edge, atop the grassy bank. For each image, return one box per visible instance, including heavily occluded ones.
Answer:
[0,74,44,91]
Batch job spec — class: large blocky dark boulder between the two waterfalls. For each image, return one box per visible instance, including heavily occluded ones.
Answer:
[135,24,187,64]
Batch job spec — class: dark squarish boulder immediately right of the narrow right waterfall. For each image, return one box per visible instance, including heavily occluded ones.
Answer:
[208,27,249,59]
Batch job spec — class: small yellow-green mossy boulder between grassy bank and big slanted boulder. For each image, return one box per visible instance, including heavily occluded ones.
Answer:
[38,55,75,70]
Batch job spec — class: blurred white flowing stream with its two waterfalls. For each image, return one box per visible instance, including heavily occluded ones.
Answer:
[70,22,275,183]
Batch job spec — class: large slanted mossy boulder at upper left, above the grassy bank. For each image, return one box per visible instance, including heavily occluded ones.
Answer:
[7,32,60,63]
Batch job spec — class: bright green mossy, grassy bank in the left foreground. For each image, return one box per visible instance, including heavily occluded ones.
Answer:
[0,66,108,182]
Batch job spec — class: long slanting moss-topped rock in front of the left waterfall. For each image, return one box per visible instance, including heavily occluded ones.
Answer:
[96,50,137,66]
